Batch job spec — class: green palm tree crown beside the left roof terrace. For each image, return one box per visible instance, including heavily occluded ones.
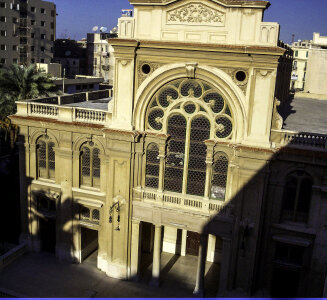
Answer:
[0,64,56,101]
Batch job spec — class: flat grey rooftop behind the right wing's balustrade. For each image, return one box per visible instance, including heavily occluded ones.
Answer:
[281,98,327,134]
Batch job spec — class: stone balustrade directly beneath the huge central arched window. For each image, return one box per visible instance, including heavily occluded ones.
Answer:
[133,187,234,217]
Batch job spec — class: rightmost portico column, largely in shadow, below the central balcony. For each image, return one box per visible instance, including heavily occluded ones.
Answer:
[193,234,208,297]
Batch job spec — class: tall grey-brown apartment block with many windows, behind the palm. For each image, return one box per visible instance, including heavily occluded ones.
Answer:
[0,0,56,66]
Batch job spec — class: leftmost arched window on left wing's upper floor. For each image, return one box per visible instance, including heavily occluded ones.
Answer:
[36,136,56,180]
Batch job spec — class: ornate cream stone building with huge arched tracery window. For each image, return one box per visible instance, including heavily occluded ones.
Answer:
[11,0,327,297]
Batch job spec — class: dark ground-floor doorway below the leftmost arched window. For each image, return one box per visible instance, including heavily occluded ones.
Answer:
[39,218,56,253]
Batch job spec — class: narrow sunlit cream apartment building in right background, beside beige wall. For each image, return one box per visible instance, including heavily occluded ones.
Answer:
[291,40,312,91]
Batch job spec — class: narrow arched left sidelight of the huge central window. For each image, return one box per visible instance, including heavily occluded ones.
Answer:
[145,143,160,189]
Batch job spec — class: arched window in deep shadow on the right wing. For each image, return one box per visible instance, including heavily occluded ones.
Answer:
[281,171,313,223]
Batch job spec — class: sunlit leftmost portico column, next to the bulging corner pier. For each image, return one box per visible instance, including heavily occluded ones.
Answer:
[130,220,142,281]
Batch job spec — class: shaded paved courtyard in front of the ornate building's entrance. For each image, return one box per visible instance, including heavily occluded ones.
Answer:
[0,253,219,298]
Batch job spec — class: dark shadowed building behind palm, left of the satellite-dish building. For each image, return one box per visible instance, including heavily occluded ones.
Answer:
[53,39,87,78]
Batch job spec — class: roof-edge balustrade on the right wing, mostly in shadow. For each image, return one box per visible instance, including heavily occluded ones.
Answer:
[271,130,327,151]
